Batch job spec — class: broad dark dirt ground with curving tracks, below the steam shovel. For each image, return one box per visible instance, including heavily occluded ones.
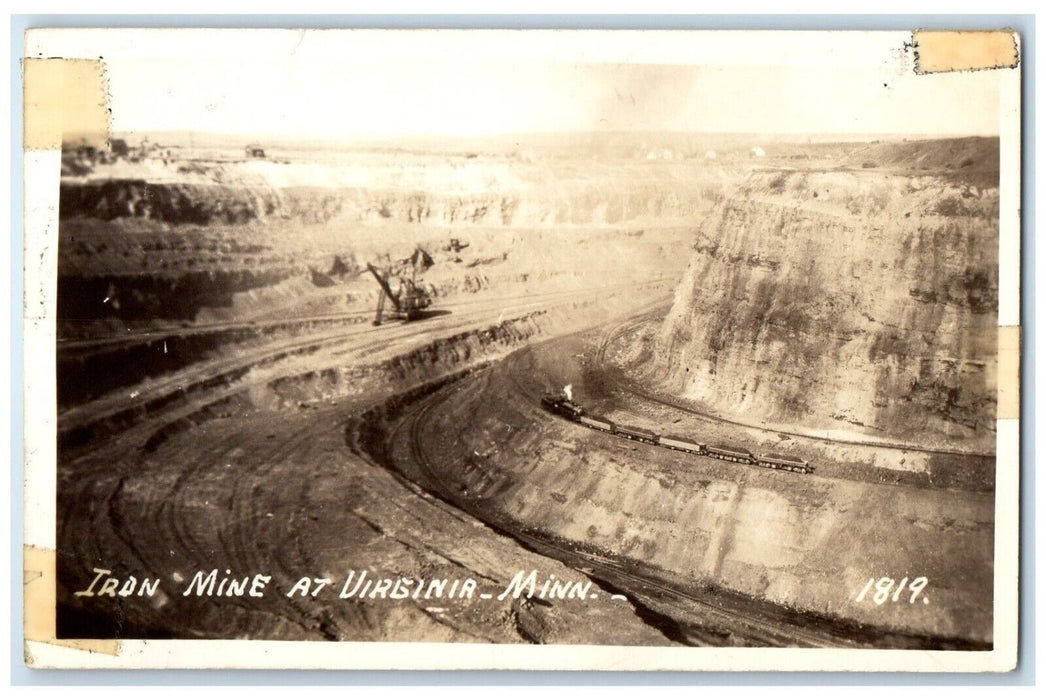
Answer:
[58,276,672,645]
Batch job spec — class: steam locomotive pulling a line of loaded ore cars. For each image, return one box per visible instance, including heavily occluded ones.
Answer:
[541,393,814,474]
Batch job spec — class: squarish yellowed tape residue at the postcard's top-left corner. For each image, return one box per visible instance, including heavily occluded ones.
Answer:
[22,59,109,151]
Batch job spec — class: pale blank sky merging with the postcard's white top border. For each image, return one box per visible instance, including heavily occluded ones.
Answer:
[27,29,999,139]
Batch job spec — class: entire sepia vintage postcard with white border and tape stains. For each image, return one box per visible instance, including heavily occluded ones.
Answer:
[23,27,1022,672]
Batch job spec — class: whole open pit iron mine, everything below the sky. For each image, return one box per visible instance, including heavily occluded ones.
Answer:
[56,133,999,649]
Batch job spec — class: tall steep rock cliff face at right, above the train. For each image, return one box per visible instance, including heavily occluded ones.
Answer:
[646,171,999,450]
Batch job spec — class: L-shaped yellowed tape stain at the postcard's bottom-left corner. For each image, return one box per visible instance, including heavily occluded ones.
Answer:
[22,545,120,665]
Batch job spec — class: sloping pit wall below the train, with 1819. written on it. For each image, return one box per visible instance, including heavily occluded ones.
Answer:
[425,382,994,646]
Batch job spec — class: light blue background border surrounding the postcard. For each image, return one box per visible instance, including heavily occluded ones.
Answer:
[9,15,1036,685]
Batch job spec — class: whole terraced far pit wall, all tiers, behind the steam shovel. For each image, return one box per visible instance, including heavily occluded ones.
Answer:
[59,159,720,337]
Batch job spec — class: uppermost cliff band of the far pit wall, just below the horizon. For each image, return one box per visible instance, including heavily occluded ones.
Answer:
[60,165,718,226]
